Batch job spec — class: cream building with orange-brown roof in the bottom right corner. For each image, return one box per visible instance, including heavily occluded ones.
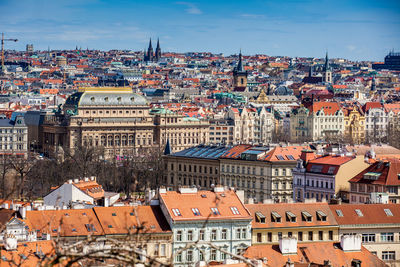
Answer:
[329,204,400,267]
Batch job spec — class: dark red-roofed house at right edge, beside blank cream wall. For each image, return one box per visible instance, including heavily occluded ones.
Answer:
[349,159,400,204]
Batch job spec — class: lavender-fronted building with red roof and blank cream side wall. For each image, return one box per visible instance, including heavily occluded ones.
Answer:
[293,151,368,202]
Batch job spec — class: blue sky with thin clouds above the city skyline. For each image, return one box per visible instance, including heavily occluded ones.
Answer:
[0,0,400,61]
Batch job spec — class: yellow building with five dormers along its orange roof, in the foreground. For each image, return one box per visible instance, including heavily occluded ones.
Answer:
[246,203,339,245]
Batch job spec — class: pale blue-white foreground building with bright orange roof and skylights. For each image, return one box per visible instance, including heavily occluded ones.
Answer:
[159,186,252,266]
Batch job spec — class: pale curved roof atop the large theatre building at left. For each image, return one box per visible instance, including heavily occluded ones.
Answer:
[65,90,148,106]
